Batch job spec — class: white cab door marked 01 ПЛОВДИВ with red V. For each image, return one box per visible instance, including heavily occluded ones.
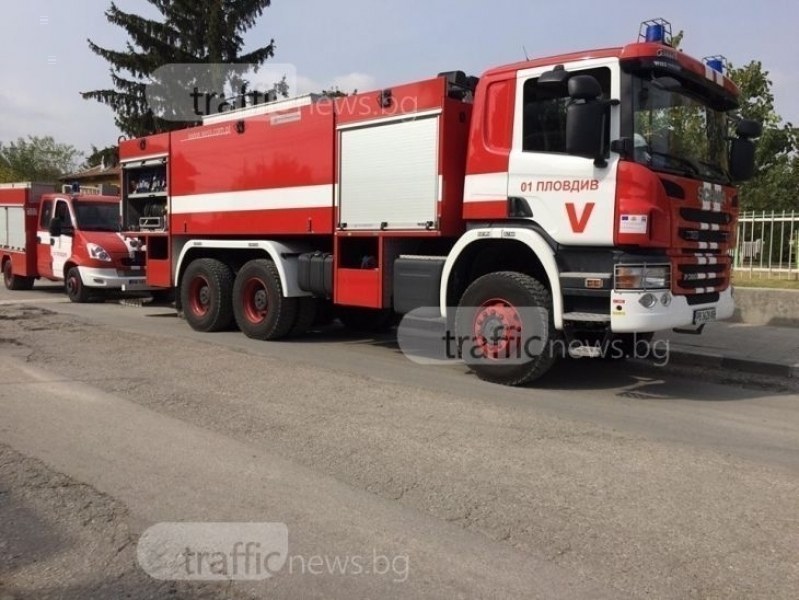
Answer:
[508,59,620,246]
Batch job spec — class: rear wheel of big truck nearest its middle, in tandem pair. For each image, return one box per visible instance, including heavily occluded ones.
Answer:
[233,259,298,340]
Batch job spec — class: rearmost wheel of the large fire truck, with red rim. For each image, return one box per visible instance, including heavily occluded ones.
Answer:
[180,258,233,332]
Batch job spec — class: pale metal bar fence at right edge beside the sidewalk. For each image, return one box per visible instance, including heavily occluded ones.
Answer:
[733,210,799,279]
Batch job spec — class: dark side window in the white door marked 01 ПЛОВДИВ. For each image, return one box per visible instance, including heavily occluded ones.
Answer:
[522,67,610,154]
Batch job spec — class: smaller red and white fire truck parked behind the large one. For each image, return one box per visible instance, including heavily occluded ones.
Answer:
[0,183,145,302]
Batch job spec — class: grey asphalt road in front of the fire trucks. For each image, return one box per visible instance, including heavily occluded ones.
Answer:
[0,287,799,600]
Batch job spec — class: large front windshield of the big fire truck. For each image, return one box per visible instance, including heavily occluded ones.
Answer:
[633,77,730,184]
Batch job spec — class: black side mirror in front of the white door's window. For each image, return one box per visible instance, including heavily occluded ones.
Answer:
[566,75,608,167]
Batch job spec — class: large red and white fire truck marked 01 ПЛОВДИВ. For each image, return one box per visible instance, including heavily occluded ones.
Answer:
[120,21,759,384]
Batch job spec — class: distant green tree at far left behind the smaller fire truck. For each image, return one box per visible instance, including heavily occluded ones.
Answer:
[0,136,81,183]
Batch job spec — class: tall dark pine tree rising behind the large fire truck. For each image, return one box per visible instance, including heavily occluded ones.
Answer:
[81,0,275,137]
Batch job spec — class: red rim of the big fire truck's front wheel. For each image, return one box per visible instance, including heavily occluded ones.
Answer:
[472,298,522,360]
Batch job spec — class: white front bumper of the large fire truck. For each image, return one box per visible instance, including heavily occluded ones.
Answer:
[610,287,735,333]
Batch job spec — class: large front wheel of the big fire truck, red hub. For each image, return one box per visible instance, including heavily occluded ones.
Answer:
[455,271,560,385]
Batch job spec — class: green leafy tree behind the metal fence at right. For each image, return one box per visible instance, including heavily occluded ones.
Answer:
[729,61,799,210]
